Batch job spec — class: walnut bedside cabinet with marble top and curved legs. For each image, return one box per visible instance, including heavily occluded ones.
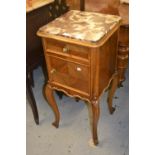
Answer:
[37,10,121,145]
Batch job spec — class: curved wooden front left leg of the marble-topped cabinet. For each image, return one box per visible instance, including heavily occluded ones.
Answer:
[45,84,60,128]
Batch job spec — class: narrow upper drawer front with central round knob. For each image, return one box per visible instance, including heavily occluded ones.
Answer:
[46,39,90,61]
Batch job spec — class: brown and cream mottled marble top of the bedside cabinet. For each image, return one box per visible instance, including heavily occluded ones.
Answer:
[39,10,121,42]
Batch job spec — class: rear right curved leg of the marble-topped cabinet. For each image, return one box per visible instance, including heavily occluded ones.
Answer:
[107,74,118,114]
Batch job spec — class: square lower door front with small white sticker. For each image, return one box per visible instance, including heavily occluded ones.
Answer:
[46,55,90,94]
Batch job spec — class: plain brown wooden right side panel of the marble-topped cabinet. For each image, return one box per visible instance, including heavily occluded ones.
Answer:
[99,31,118,95]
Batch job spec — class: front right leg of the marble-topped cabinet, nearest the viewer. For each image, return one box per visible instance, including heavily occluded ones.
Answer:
[92,100,100,145]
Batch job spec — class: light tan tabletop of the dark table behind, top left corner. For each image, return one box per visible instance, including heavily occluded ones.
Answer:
[26,0,54,13]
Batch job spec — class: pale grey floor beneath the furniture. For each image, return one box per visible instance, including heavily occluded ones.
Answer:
[26,68,129,155]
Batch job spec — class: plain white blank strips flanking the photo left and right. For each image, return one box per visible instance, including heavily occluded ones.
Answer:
[0,0,155,155]
